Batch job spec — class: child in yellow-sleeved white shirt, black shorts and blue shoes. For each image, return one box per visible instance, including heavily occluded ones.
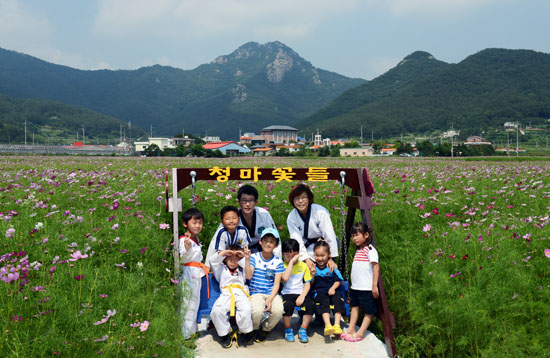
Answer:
[282,239,314,343]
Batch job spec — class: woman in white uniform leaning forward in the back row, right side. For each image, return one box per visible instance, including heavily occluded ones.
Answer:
[286,184,338,273]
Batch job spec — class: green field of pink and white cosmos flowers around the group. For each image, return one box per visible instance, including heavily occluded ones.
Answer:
[0,156,550,357]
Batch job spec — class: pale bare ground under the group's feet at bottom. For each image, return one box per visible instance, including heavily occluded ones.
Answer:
[195,315,388,358]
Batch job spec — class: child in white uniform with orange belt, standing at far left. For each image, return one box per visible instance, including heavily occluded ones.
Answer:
[179,208,205,339]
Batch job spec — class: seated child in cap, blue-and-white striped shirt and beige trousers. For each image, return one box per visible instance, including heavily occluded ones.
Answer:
[245,228,285,343]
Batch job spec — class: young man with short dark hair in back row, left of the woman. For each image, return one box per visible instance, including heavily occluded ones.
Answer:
[237,184,281,257]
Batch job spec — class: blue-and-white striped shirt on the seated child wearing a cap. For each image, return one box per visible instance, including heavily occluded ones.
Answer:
[249,252,285,295]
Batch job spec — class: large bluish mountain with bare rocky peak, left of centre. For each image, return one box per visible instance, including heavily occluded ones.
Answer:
[0,42,366,138]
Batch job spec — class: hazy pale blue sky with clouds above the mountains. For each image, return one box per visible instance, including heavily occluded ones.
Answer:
[0,0,550,80]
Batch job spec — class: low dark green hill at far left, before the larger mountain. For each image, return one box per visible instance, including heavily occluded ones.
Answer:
[0,95,146,144]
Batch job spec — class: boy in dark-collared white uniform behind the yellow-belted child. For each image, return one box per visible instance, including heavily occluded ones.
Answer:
[205,205,250,266]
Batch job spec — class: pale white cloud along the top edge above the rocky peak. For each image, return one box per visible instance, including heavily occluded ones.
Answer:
[94,0,362,38]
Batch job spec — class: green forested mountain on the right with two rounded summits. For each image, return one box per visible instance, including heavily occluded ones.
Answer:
[296,49,550,137]
